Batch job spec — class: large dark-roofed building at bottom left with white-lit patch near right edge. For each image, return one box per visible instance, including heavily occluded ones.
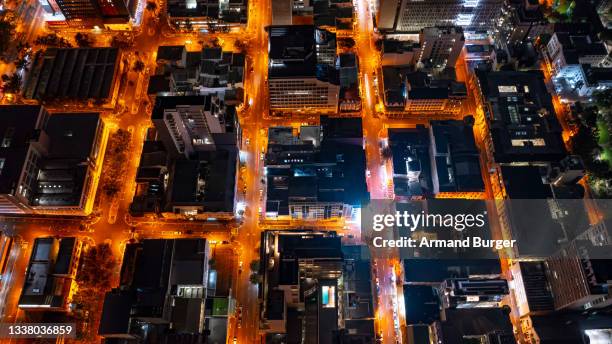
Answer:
[98,239,213,341]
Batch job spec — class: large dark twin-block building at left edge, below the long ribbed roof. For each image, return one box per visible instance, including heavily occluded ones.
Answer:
[0,105,104,206]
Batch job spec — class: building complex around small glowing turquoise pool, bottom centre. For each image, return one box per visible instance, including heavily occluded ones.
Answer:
[260,231,374,344]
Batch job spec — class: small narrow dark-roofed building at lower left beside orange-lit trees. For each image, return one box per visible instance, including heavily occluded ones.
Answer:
[18,237,83,311]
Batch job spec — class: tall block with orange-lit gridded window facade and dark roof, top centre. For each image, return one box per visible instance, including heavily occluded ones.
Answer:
[268,25,340,115]
